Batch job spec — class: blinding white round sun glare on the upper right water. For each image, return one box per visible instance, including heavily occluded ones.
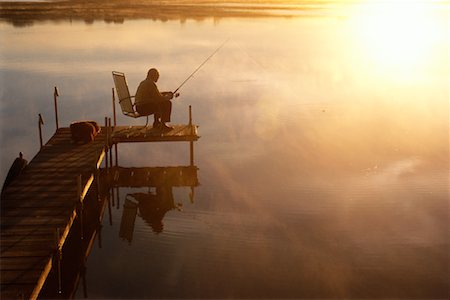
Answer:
[352,1,448,75]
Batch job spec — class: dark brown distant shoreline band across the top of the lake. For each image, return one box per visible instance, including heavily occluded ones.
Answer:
[0,0,332,27]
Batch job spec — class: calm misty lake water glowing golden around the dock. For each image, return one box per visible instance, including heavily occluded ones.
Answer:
[0,2,450,299]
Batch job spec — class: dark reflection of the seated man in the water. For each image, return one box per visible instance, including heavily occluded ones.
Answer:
[130,185,181,233]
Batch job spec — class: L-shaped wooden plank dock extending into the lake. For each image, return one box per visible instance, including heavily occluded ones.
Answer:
[0,121,199,299]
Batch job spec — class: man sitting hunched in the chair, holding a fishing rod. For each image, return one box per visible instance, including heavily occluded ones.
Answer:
[136,68,173,129]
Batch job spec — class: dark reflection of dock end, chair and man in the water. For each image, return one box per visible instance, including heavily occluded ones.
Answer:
[112,166,199,243]
